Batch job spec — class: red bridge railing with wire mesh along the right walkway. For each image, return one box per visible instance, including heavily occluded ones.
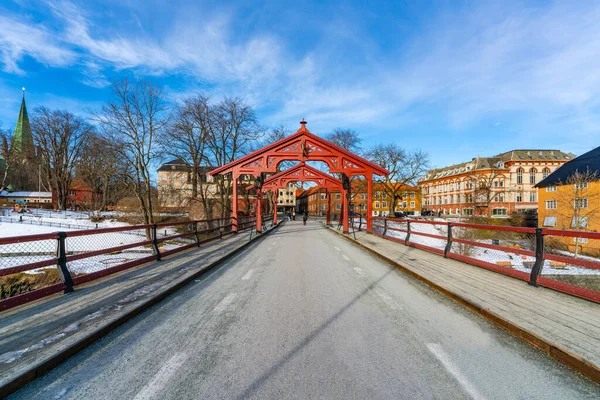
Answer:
[373,217,600,302]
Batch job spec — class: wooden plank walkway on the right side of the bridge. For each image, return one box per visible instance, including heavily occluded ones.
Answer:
[331,229,600,382]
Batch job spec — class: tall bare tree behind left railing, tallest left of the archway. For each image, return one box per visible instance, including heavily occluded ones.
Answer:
[95,78,168,228]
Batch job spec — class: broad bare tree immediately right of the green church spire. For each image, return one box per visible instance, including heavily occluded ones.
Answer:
[31,107,94,210]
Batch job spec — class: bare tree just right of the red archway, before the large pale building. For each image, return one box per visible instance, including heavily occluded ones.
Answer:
[365,143,429,214]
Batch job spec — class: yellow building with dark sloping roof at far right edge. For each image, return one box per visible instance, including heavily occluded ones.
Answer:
[536,147,600,255]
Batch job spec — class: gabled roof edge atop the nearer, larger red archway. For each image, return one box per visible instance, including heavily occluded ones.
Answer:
[210,119,389,176]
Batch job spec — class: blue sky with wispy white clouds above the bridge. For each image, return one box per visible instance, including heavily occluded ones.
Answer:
[0,0,600,167]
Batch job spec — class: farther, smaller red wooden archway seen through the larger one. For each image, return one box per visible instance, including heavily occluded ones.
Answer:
[248,162,343,224]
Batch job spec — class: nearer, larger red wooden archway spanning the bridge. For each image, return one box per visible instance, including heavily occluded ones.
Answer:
[210,120,389,233]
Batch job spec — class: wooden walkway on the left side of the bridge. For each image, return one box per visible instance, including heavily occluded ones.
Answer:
[0,223,274,398]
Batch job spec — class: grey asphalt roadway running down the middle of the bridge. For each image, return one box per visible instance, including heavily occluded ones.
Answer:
[13,221,600,400]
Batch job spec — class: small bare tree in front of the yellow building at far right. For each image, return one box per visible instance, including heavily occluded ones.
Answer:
[556,168,600,257]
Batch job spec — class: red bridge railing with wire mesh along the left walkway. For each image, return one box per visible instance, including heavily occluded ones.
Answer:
[0,218,241,311]
